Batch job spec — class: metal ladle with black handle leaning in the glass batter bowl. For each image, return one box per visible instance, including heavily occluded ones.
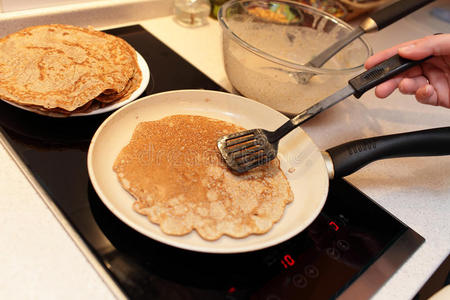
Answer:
[291,0,434,84]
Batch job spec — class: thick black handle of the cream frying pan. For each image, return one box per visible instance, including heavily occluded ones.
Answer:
[326,127,450,178]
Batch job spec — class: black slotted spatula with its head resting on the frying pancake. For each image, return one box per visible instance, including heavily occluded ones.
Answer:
[217,55,429,173]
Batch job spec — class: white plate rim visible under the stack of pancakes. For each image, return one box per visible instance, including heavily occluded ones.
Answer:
[2,51,150,118]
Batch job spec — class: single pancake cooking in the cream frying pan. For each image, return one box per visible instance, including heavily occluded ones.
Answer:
[113,115,293,240]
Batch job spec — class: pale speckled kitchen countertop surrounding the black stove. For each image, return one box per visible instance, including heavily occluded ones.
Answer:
[0,1,450,299]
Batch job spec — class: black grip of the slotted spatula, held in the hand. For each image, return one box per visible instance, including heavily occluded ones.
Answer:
[348,54,430,98]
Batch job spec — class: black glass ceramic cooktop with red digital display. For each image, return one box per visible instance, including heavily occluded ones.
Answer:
[0,26,424,300]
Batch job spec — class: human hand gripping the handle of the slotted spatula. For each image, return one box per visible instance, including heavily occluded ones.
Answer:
[365,34,450,108]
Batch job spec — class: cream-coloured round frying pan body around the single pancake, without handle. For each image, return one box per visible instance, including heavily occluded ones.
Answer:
[88,90,329,253]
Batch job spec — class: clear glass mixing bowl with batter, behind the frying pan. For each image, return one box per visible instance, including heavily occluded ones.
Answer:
[218,0,372,116]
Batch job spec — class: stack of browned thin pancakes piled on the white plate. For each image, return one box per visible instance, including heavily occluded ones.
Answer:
[0,24,142,115]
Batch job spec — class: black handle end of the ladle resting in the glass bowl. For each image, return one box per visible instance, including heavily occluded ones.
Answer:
[369,0,434,30]
